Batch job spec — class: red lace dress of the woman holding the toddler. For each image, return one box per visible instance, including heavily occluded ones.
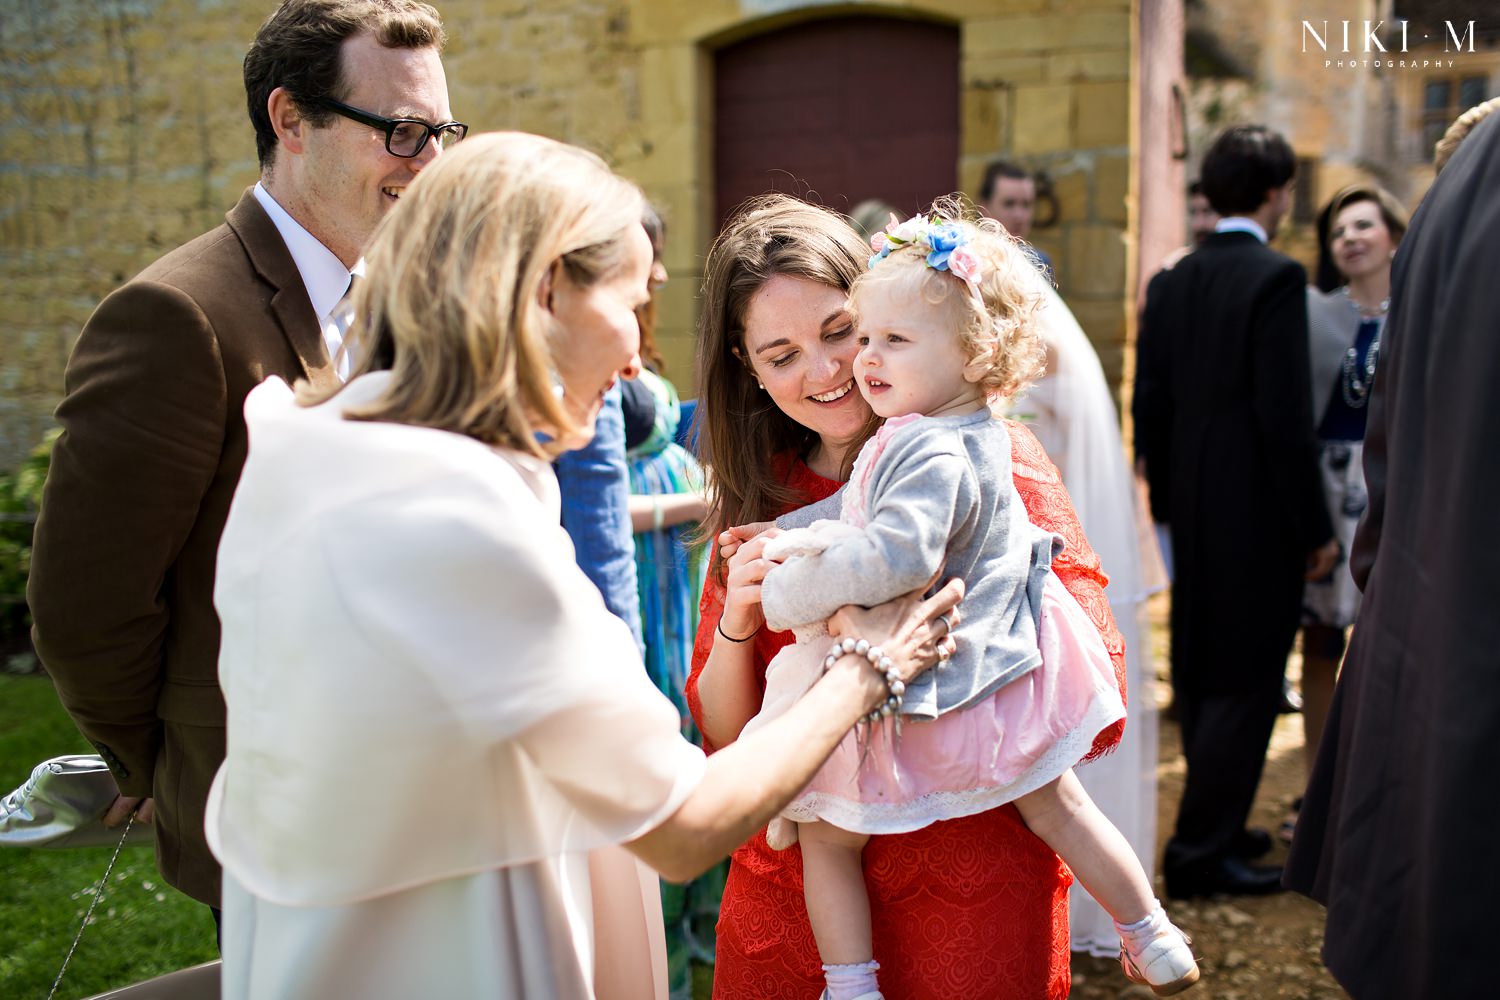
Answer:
[686,421,1125,1000]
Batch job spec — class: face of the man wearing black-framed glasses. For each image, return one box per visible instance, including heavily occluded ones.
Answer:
[267,31,452,267]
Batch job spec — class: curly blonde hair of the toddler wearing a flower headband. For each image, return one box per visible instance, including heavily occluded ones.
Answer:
[849,195,1046,396]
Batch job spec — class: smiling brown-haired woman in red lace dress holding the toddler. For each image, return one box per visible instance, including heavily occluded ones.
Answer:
[687,196,1124,1000]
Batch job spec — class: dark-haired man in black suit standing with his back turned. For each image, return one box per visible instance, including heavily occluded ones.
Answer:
[1134,126,1338,898]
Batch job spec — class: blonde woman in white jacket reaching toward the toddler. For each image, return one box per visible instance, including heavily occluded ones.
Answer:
[207,133,962,1000]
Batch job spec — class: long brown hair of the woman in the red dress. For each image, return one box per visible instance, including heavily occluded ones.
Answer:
[695,195,879,554]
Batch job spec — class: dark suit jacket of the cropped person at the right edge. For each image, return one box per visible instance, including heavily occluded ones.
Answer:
[1287,117,1500,1000]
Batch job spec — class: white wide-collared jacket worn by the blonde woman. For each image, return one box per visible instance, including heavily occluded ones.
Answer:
[207,373,705,996]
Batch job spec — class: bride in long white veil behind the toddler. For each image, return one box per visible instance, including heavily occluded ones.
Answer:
[1011,276,1167,957]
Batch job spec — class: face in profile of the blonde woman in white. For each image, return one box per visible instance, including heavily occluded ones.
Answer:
[548,226,651,447]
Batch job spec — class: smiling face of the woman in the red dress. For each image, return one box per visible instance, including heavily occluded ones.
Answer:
[744,274,870,472]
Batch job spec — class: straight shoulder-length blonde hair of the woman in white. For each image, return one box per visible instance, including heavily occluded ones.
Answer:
[305,132,644,457]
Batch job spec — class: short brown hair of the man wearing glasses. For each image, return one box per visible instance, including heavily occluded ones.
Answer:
[245,0,447,171]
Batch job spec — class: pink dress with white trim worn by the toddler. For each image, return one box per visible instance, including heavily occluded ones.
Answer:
[744,418,1125,849]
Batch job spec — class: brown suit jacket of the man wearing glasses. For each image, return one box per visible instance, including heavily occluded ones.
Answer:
[27,192,338,906]
